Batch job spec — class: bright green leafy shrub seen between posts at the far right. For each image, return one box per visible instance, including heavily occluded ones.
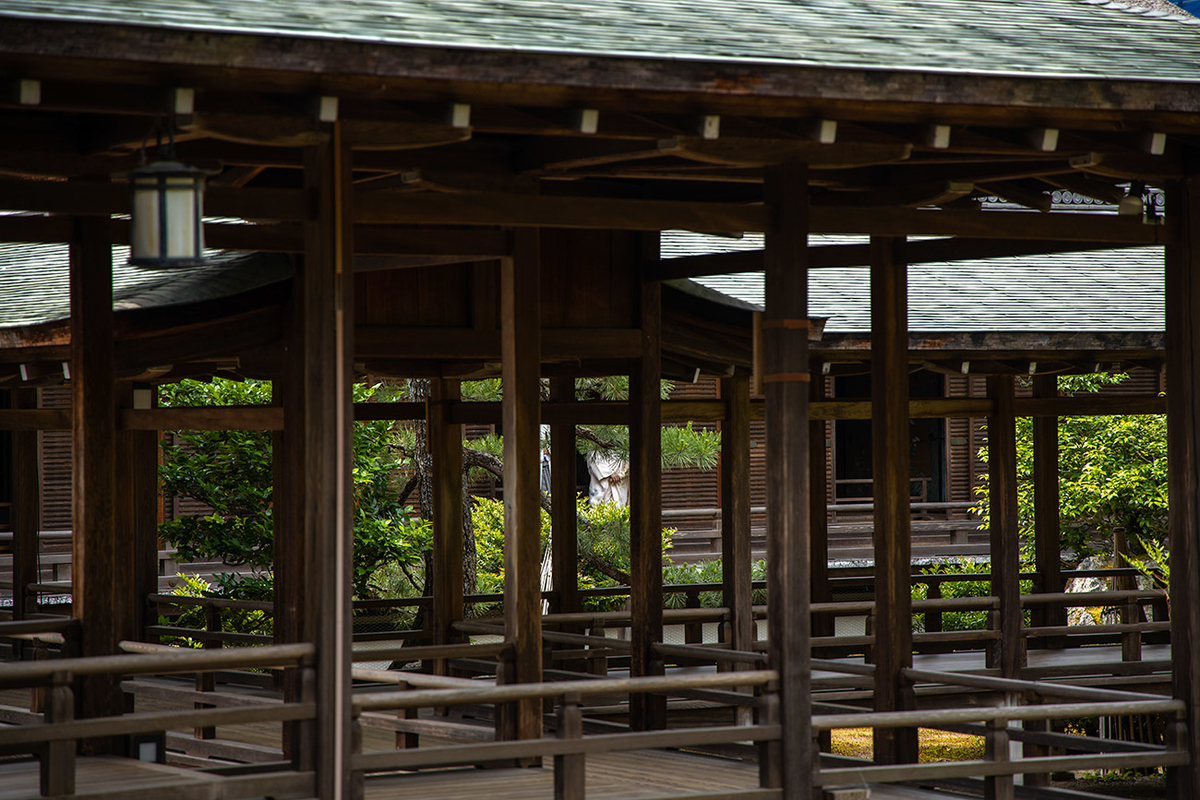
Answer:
[977,374,1166,558]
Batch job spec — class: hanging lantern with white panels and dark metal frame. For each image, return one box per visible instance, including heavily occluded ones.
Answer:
[128,158,205,270]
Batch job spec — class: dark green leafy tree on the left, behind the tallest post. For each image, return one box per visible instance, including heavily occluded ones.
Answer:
[160,379,430,597]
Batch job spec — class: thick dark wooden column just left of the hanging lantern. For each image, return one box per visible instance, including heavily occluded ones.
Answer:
[71,217,123,724]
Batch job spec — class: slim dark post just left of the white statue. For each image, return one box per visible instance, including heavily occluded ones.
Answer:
[550,378,580,613]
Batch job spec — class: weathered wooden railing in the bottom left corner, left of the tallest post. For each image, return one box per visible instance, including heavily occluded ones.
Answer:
[0,643,317,798]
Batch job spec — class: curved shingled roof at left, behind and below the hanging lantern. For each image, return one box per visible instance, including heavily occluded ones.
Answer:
[0,225,292,329]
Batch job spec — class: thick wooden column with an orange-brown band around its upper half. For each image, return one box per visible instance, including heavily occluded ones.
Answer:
[763,164,814,800]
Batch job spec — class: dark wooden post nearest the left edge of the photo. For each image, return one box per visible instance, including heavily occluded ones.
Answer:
[12,389,42,619]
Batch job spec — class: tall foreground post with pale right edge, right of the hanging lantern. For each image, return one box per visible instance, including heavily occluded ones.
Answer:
[296,122,354,800]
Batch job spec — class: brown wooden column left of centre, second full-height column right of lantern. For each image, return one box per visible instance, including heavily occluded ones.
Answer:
[499,228,541,739]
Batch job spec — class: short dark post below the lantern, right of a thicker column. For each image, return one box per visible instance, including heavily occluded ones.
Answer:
[115,383,158,639]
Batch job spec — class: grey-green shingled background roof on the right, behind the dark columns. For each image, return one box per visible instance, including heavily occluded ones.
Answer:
[662,231,1164,333]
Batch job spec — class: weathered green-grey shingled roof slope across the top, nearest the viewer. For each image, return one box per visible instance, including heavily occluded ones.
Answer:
[0,0,1200,80]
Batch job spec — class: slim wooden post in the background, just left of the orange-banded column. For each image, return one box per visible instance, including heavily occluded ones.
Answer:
[721,373,755,651]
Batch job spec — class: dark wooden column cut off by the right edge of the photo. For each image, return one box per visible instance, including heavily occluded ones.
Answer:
[1166,161,1200,800]
